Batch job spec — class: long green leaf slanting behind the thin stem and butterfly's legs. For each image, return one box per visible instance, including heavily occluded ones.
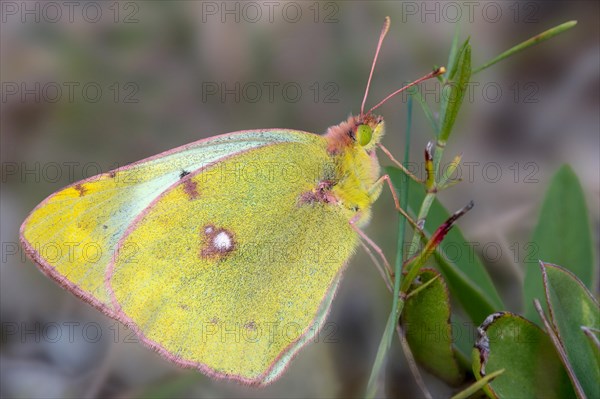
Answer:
[386,173,504,324]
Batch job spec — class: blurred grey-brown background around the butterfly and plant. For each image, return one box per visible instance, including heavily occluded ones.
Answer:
[0,1,600,398]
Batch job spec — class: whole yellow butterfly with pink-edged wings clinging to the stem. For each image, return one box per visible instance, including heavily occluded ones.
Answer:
[20,18,444,385]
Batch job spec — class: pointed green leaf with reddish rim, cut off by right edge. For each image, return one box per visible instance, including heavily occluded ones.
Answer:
[540,262,600,398]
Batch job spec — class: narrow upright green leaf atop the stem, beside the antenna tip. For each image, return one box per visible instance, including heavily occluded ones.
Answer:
[438,40,471,142]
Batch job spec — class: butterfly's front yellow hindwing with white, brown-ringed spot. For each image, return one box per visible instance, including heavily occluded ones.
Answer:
[107,134,358,384]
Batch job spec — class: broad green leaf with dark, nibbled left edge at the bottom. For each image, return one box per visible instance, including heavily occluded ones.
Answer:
[473,312,575,398]
